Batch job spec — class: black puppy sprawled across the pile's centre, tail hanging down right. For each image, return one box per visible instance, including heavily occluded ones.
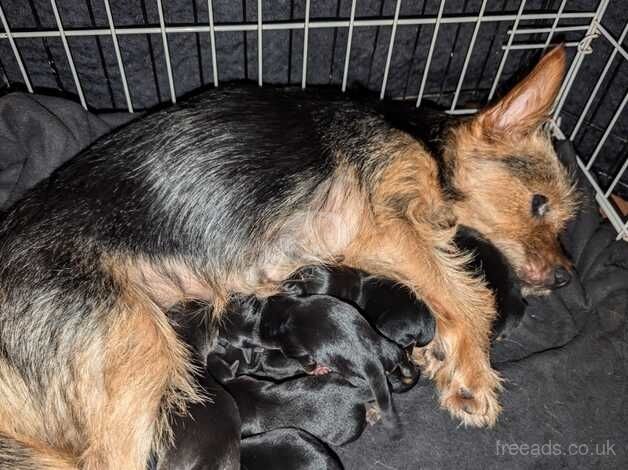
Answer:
[221,295,418,428]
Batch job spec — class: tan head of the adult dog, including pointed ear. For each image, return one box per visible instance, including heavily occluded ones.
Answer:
[452,46,577,293]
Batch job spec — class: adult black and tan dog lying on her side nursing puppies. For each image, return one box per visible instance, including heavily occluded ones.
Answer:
[0,48,575,469]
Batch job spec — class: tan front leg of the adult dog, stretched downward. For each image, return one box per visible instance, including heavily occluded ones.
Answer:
[346,219,501,426]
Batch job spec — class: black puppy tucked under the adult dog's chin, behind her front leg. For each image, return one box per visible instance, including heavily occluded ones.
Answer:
[454,227,526,341]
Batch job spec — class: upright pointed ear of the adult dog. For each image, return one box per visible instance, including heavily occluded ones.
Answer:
[476,44,566,135]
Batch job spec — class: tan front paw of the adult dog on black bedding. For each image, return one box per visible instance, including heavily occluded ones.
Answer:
[437,369,502,427]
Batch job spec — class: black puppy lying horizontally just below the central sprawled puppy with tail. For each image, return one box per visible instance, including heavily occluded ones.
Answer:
[208,354,371,445]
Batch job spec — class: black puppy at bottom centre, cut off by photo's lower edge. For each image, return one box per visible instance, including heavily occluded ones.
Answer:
[240,429,343,470]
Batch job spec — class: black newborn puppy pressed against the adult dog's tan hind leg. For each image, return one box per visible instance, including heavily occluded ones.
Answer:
[156,374,241,470]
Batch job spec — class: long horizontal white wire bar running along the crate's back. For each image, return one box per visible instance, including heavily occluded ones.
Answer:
[0,12,595,39]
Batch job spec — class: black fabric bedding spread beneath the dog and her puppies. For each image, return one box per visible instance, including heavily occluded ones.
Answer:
[0,93,628,470]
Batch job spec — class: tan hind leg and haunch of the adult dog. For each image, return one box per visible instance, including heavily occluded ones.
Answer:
[0,291,200,470]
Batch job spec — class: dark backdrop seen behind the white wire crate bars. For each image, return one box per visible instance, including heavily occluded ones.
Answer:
[0,0,628,197]
